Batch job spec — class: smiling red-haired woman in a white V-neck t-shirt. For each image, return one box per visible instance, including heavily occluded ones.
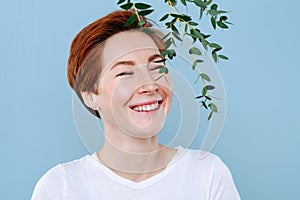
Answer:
[32,11,240,200]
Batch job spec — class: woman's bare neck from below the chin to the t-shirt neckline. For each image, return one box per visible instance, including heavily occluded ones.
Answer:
[97,123,176,182]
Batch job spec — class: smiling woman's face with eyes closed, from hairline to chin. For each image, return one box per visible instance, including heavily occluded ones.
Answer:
[94,31,172,138]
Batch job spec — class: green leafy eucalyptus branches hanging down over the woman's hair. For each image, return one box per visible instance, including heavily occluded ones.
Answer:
[117,0,232,119]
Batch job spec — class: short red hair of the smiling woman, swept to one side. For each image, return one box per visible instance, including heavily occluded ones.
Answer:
[68,11,163,118]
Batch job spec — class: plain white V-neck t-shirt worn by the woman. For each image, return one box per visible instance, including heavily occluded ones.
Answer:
[32,147,240,200]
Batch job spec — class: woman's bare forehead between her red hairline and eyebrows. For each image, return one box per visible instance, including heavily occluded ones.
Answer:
[102,31,159,66]
